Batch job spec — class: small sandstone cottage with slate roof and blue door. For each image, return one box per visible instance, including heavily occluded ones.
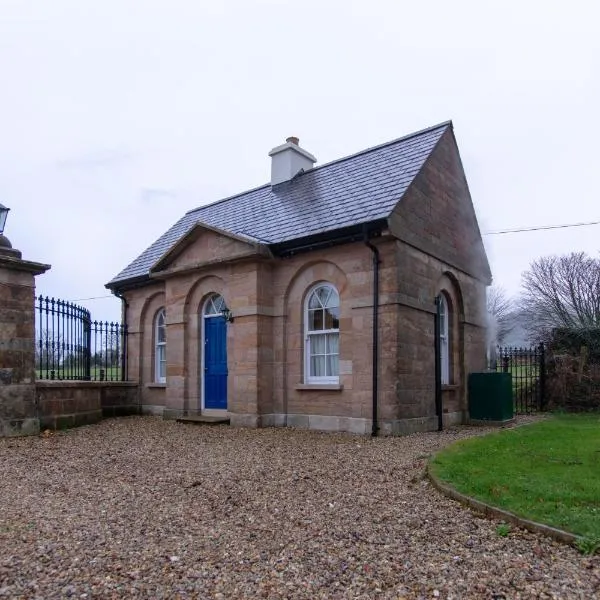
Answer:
[107,122,491,434]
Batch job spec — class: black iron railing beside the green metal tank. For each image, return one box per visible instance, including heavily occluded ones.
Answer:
[495,344,546,414]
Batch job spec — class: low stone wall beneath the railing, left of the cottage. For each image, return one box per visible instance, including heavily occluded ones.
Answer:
[35,380,140,430]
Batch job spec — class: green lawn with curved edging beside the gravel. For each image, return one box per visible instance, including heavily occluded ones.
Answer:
[432,414,600,539]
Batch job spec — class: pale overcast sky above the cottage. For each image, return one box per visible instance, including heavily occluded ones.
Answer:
[0,0,600,318]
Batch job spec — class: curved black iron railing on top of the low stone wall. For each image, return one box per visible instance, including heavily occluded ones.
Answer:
[35,296,127,381]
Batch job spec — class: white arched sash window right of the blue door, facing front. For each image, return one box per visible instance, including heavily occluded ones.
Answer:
[304,283,340,383]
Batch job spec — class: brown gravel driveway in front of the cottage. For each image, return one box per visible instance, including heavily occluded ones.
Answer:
[0,417,600,599]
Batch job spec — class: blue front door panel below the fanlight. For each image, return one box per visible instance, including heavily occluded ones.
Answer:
[204,316,227,409]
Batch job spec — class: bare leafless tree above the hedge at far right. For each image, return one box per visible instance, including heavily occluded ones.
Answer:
[520,252,600,341]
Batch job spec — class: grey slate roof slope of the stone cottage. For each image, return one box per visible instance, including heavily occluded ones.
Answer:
[107,121,452,287]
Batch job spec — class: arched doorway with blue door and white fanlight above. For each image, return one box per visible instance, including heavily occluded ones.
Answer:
[199,294,227,410]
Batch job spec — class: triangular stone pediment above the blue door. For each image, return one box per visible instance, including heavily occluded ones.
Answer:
[150,223,269,275]
